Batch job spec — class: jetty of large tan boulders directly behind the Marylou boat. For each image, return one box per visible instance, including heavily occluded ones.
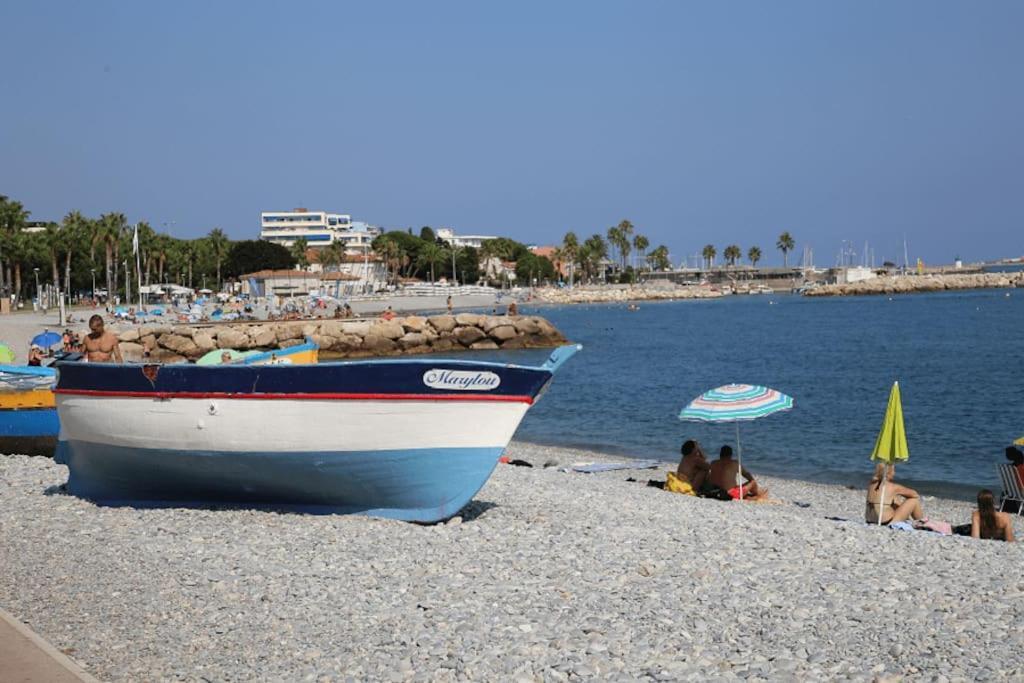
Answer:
[101,313,566,362]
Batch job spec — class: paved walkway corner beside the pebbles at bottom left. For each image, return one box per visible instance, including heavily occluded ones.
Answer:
[0,609,99,683]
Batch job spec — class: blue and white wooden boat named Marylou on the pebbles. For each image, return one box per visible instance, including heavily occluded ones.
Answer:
[56,346,579,522]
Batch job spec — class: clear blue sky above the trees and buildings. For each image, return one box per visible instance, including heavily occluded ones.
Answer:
[0,0,1024,265]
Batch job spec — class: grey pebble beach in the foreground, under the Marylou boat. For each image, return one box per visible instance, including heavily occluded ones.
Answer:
[0,442,1024,681]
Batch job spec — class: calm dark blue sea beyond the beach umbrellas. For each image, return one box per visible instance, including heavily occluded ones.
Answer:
[481,290,1024,498]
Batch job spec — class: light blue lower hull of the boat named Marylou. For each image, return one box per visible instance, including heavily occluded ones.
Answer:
[56,440,504,521]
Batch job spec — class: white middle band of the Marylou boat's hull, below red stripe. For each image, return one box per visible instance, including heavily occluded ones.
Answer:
[56,394,529,454]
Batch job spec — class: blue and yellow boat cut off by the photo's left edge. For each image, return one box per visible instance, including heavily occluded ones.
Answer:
[0,366,57,456]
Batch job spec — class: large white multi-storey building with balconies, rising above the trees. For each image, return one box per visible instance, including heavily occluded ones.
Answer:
[259,208,380,254]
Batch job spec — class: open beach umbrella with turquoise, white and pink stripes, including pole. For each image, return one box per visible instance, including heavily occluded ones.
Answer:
[679,384,793,499]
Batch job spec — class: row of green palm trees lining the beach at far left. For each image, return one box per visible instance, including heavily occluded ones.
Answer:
[0,196,231,299]
